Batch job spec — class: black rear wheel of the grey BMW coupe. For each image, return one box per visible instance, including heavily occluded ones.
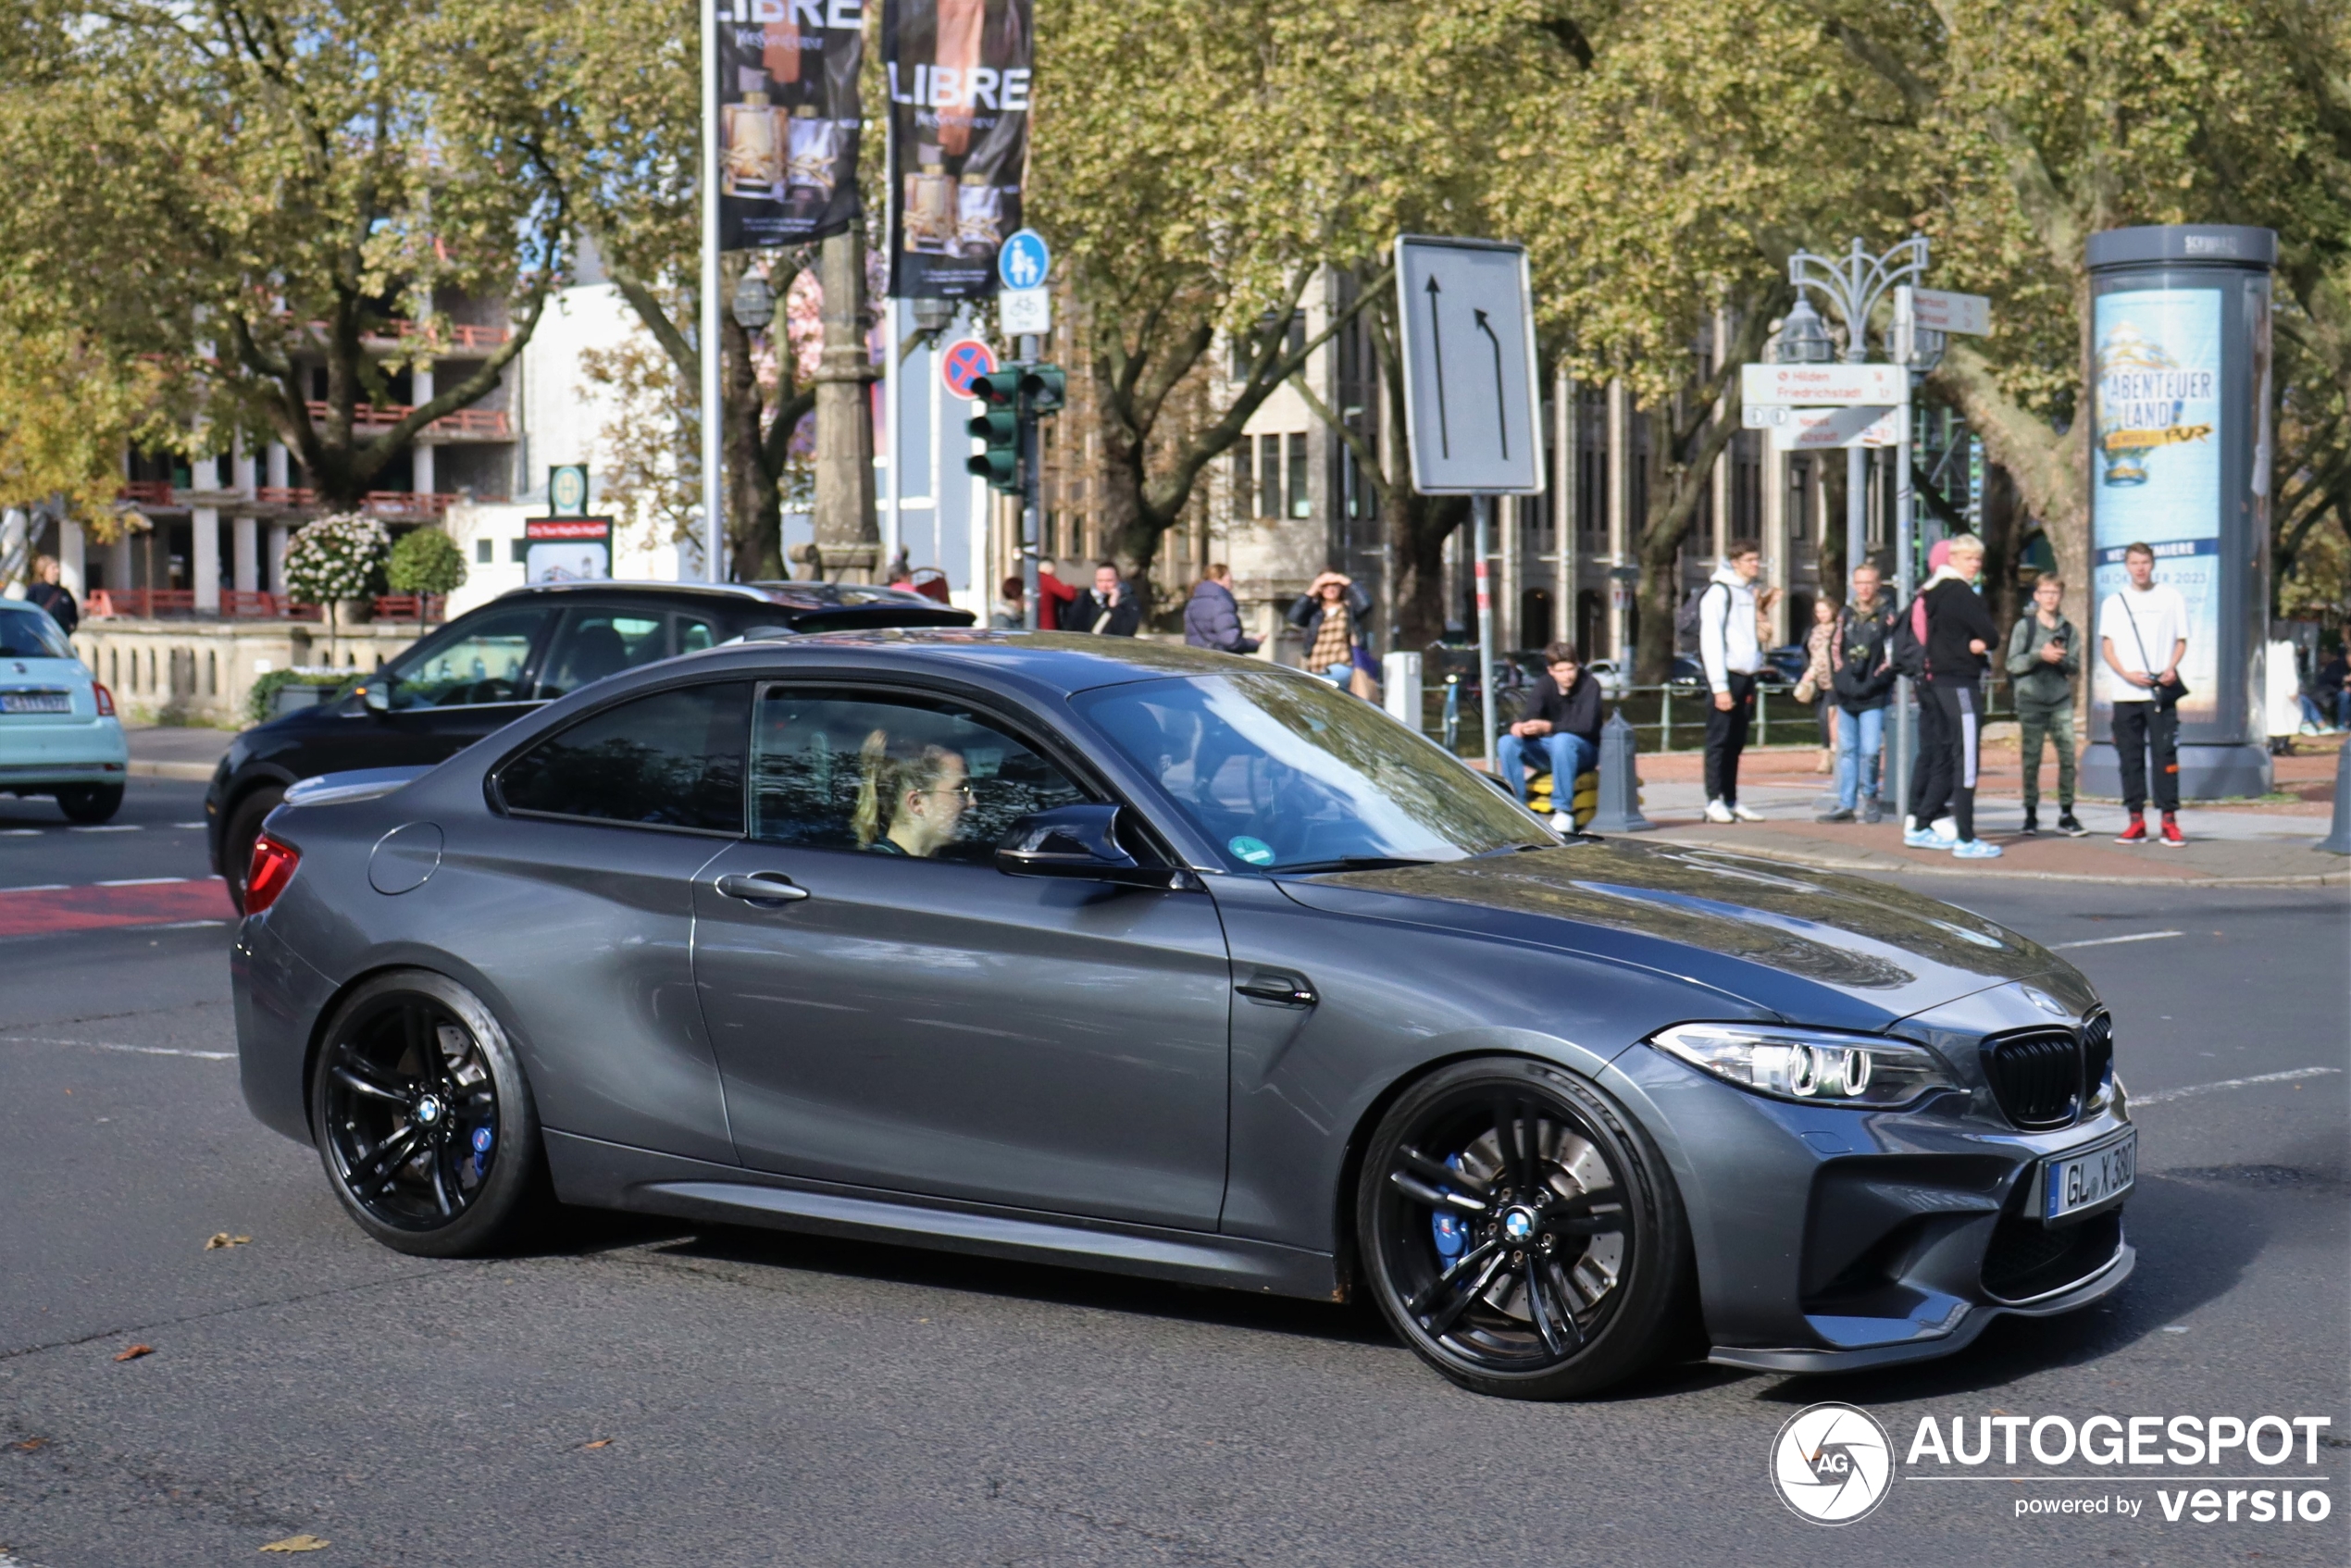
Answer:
[310,971,541,1258]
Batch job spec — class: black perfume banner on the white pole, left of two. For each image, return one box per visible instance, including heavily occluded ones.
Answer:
[710,0,865,252]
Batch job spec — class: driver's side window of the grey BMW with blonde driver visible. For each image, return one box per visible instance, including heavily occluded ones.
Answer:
[753,687,1091,865]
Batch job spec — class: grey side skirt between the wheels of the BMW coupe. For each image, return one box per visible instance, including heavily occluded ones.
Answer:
[545,1131,1342,1300]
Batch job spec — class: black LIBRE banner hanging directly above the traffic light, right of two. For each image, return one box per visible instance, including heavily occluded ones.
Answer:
[882,0,1035,299]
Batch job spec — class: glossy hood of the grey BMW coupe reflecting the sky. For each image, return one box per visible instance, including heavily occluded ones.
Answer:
[1281,840,2090,1029]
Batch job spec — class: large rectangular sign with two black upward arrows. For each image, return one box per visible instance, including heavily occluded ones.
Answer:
[1397,235,1542,496]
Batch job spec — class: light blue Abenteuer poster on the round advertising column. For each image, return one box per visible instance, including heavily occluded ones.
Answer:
[2090,289,2233,731]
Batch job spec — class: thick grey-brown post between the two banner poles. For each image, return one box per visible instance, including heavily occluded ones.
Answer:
[811,226,884,583]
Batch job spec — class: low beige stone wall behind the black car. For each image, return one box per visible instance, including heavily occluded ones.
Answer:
[73,618,430,728]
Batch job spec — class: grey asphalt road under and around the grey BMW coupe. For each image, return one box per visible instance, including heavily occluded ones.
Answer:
[0,783,2351,1568]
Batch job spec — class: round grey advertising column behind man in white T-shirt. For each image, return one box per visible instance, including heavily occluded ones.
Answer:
[2073,223,2278,800]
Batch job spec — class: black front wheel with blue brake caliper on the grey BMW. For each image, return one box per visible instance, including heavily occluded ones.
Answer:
[1357,1058,1690,1399]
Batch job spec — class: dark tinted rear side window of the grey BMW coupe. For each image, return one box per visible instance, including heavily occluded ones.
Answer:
[496,682,750,835]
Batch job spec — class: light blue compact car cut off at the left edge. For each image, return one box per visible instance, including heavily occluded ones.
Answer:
[0,600,131,823]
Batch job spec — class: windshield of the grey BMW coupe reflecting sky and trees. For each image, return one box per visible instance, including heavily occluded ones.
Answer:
[1076,670,1556,872]
